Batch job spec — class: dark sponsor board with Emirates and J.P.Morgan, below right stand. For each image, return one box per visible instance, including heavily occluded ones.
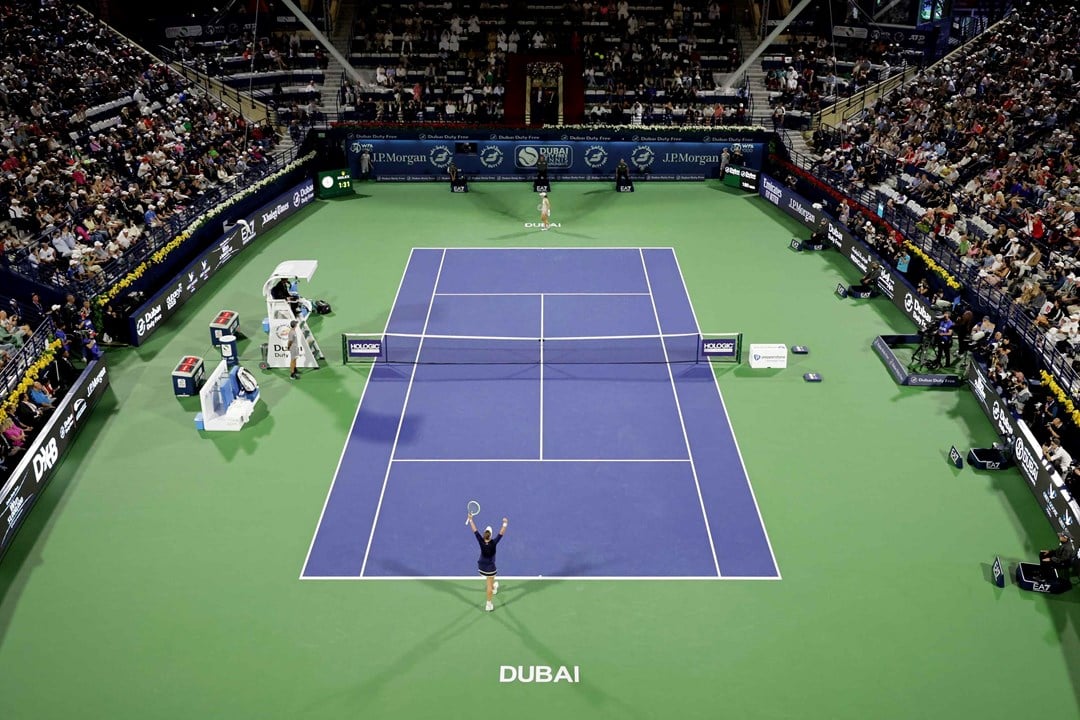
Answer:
[758,173,933,334]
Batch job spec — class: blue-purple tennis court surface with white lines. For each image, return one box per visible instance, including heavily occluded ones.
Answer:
[301,247,780,580]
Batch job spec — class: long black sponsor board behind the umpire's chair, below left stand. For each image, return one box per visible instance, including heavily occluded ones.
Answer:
[127,179,315,345]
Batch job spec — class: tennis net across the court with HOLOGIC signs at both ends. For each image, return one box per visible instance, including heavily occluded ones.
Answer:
[342,332,741,365]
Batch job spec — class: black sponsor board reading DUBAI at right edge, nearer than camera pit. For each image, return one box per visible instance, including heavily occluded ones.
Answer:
[968,363,1080,533]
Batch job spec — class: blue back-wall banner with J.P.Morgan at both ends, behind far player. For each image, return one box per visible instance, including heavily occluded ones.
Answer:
[349,139,762,180]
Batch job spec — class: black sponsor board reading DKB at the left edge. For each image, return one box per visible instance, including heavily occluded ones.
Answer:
[0,361,109,556]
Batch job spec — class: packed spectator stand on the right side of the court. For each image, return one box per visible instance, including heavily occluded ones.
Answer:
[805,2,1080,462]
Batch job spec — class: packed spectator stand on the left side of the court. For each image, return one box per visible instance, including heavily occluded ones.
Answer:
[0,1,280,297]
